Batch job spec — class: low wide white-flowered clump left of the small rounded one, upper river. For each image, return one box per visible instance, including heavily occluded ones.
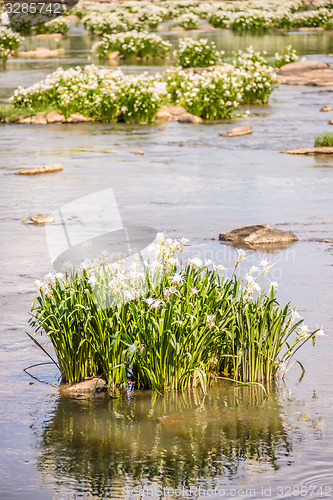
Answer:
[93,31,172,59]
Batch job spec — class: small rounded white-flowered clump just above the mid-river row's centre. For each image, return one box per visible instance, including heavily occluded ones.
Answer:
[176,38,222,68]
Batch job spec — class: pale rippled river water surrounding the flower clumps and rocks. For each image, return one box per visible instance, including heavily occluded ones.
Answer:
[0,30,333,500]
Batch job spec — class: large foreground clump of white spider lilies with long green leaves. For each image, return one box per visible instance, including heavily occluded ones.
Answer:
[29,234,323,392]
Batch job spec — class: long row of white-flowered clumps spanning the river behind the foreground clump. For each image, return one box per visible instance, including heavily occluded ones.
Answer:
[10,46,276,123]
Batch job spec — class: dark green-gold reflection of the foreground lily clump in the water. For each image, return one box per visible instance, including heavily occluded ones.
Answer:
[39,385,291,498]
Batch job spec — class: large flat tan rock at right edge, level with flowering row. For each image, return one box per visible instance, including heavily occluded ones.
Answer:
[276,61,333,86]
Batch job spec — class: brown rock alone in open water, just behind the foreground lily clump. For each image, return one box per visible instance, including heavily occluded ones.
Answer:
[219,224,298,245]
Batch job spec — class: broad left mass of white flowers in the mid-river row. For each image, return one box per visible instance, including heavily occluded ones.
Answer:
[10,65,168,123]
